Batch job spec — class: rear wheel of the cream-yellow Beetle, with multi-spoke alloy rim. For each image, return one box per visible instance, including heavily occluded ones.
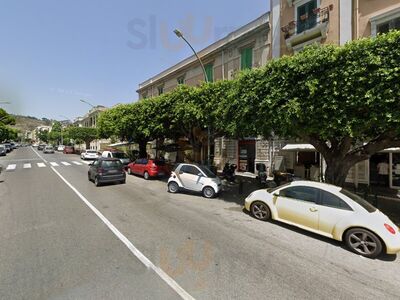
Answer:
[345,228,383,258]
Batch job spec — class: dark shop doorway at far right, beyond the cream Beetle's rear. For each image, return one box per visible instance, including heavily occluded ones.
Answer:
[369,153,389,187]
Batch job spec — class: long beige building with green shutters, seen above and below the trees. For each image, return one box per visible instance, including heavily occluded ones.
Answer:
[137,13,271,172]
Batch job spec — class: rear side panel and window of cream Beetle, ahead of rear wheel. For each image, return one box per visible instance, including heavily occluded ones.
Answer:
[318,190,354,237]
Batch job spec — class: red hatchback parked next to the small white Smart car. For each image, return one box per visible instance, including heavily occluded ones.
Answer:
[128,158,169,180]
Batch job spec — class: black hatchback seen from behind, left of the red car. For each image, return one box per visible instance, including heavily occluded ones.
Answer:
[88,158,126,186]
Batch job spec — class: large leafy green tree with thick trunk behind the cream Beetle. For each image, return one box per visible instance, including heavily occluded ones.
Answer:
[234,31,400,186]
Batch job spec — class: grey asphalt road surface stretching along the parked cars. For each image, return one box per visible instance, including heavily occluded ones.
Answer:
[0,148,400,299]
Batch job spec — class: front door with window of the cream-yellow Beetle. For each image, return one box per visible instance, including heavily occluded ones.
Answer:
[274,186,319,230]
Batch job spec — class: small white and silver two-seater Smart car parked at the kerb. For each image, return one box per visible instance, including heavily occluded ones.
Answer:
[168,163,222,198]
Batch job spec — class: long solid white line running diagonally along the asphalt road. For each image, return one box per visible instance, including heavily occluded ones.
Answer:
[47,167,194,300]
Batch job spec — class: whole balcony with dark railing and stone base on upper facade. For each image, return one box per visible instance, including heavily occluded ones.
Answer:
[281,4,333,50]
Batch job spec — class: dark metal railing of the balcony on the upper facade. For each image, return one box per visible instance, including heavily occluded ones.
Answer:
[281,4,333,39]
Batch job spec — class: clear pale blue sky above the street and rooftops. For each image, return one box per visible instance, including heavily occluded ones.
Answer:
[0,0,269,120]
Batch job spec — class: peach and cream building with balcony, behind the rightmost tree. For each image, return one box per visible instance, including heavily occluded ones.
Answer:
[267,0,400,189]
